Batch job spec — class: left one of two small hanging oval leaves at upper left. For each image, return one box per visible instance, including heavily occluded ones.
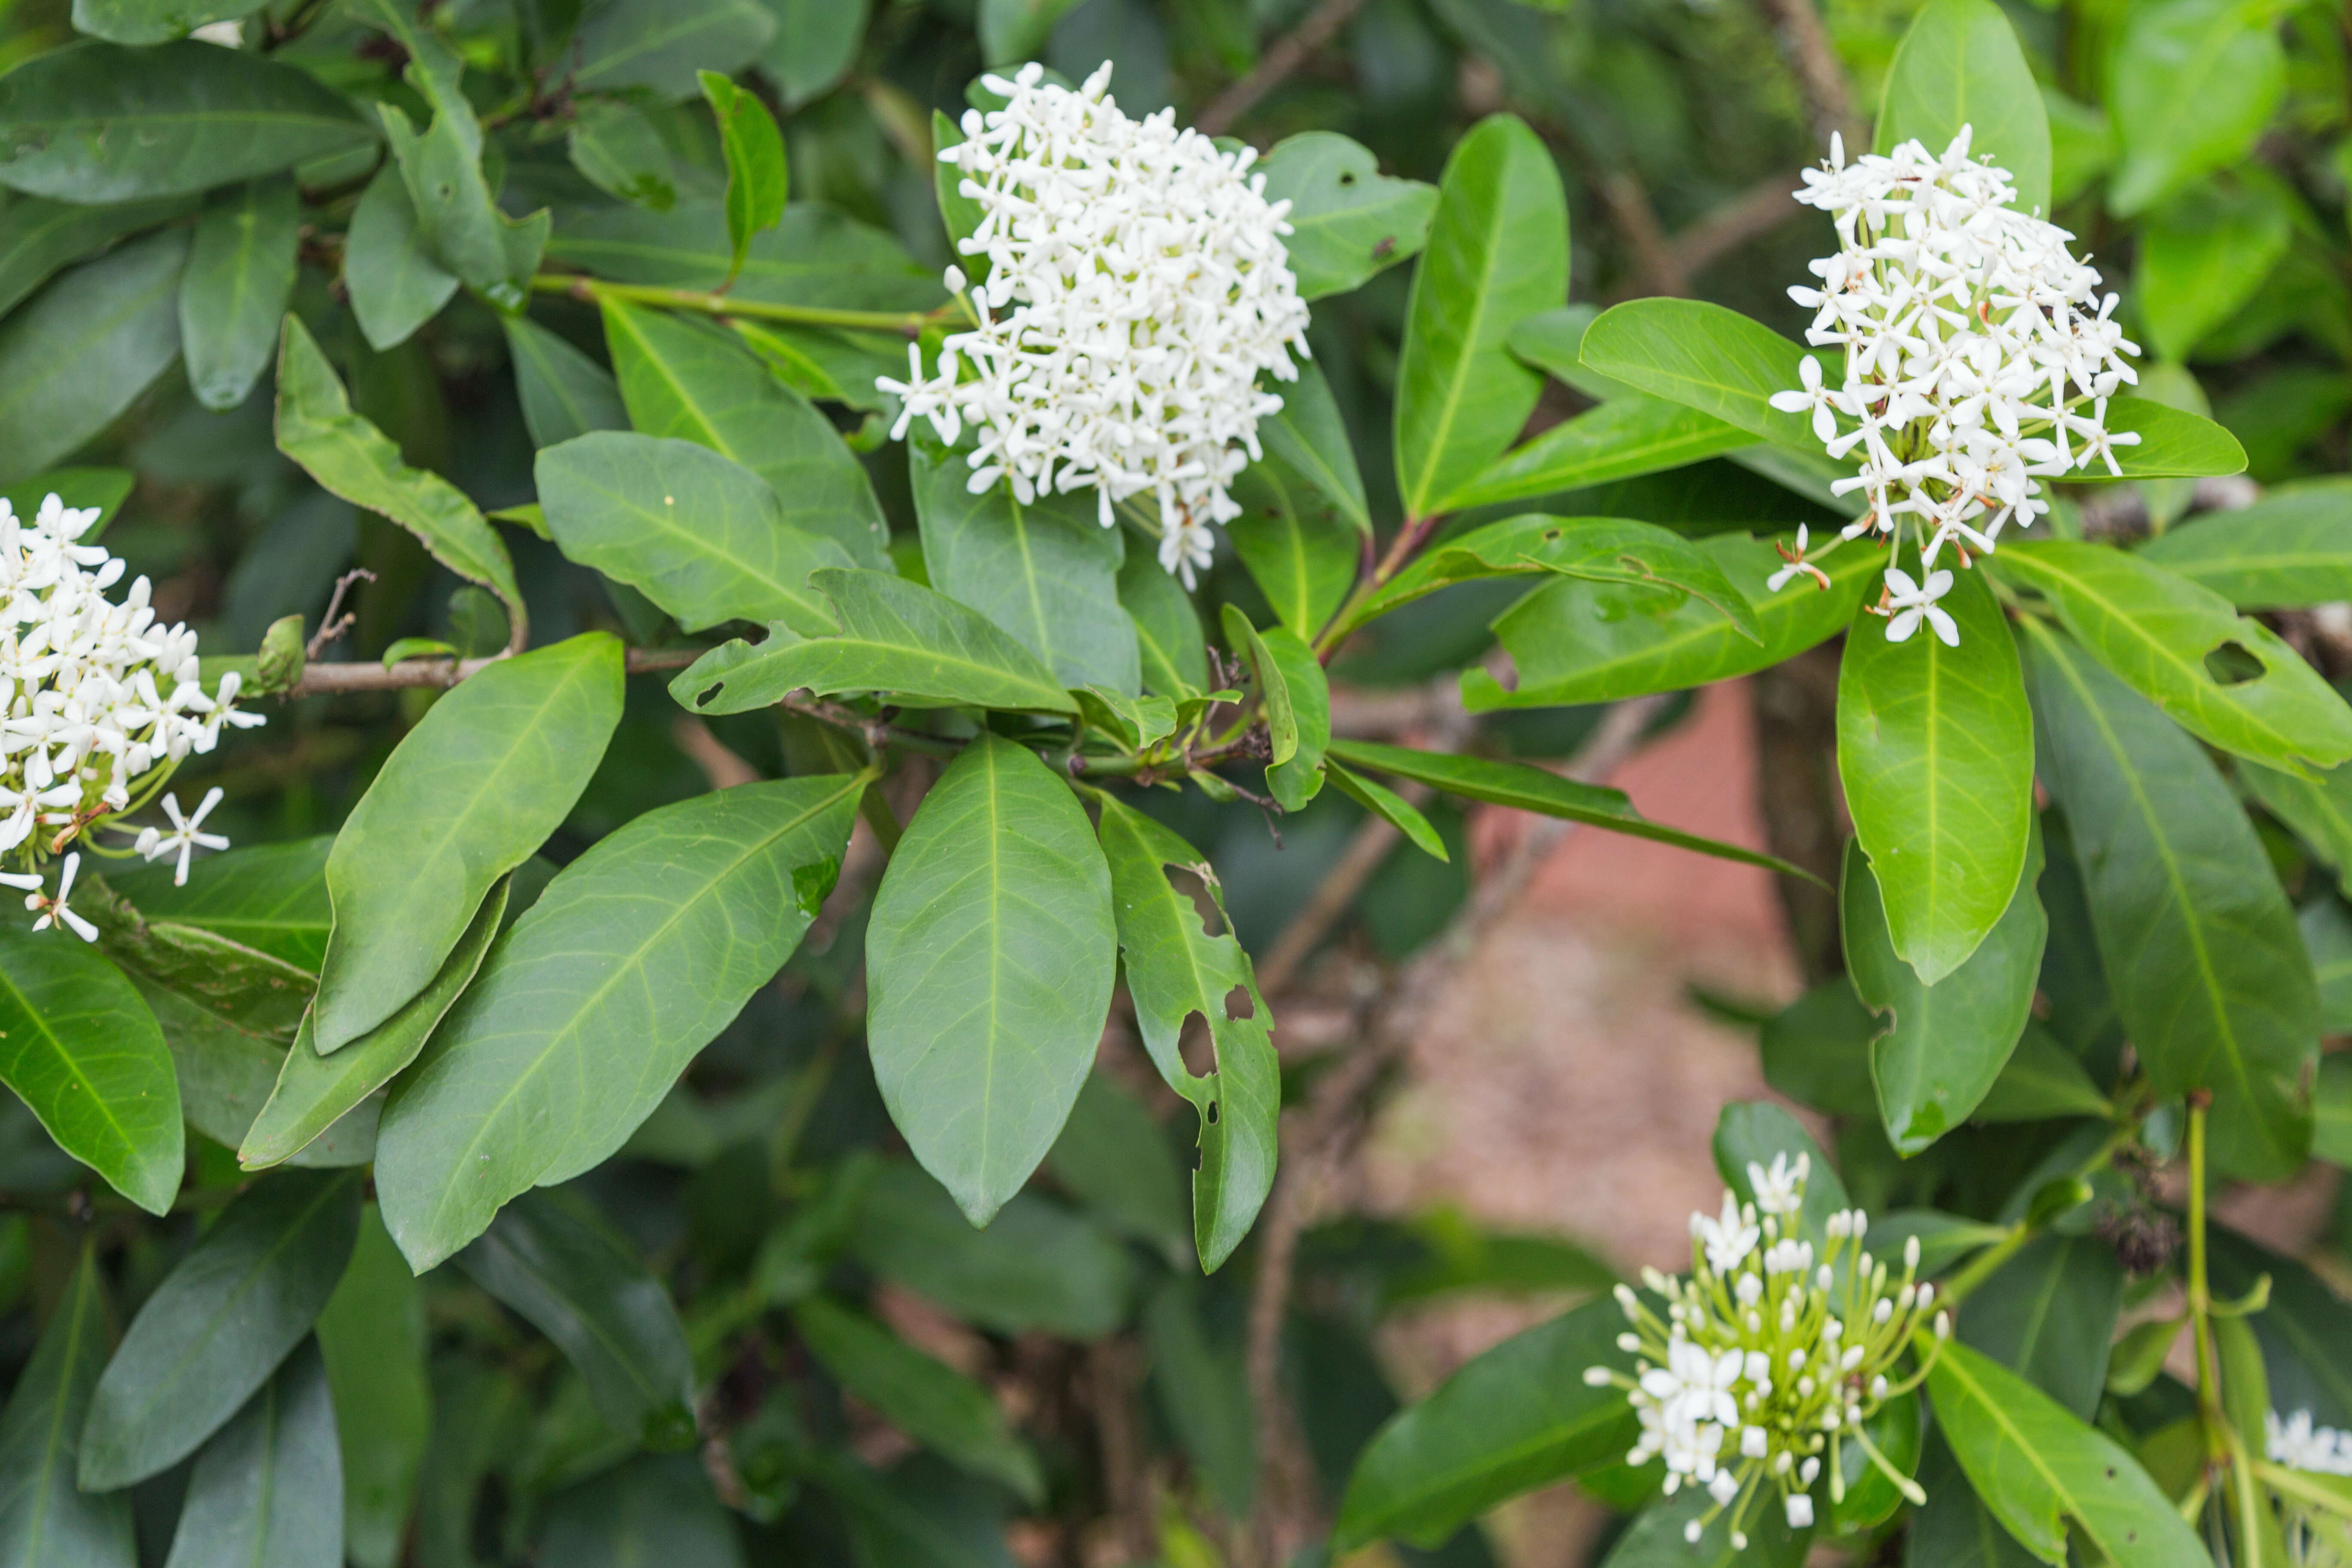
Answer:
[179,179,301,409]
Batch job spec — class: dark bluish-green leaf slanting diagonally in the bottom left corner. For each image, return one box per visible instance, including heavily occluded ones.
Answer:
[80,1171,360,1493]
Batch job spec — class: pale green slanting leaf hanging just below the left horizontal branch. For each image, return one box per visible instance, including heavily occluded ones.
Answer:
[313,632,621,1056]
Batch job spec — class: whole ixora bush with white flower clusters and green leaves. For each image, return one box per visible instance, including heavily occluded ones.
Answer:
[0,0,2352,1568]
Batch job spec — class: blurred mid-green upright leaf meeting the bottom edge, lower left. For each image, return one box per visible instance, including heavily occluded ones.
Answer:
[318,1204,433,1568]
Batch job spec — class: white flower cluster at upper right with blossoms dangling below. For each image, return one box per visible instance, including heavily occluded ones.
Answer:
[1771,125,2141,646]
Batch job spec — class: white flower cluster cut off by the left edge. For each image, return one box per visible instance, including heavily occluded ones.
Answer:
[0,494,263,938]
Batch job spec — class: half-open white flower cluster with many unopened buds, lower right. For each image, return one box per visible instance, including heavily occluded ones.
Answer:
[1585,1154,1950,1549]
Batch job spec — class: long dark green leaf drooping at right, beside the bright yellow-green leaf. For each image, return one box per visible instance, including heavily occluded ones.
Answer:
[2023,618,2319,1180]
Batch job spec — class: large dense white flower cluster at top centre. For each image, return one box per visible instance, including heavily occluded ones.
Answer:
[877,64,1308,585]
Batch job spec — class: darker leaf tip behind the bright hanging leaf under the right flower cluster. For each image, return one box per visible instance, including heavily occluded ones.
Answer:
[1842,827,2049,1157]
